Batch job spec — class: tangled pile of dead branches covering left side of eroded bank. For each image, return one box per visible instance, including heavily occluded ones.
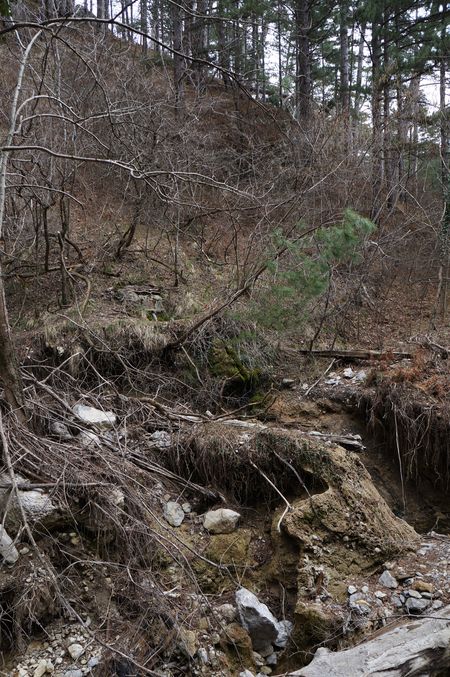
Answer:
[0,377,224,674]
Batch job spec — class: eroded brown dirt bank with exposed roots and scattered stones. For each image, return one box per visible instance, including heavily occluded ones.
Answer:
[0,344,450,677]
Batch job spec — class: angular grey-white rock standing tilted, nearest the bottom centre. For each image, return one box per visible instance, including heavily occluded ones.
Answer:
[236,588,280,651]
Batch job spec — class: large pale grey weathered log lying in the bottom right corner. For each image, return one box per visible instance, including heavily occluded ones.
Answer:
[288,607,450,677]
